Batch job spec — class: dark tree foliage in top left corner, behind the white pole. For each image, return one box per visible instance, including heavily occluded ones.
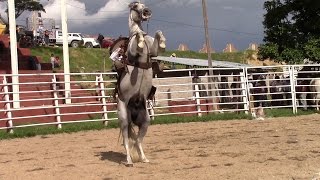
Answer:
[0,0,46,22]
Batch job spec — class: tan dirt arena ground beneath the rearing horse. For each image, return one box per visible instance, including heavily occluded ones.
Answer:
[0,115,320,180]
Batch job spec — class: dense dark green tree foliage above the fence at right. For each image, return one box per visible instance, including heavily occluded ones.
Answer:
[259,0,320,63]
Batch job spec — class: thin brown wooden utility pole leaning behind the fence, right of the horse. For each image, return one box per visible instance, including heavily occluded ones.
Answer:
[202,0,218,110]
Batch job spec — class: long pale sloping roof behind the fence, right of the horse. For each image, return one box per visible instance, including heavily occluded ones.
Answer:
[152,56,251,68]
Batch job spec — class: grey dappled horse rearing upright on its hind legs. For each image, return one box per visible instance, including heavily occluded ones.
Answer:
[117,2,166,166]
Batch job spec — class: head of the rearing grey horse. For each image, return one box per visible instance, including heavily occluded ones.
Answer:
[129,2,152,22]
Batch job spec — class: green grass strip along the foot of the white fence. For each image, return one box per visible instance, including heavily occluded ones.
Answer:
[0,109,315,140]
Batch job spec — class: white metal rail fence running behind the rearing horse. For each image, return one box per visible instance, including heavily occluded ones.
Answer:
[0,65,320,132]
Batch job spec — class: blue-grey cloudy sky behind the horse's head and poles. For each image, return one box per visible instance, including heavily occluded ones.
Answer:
[0,0,265,52]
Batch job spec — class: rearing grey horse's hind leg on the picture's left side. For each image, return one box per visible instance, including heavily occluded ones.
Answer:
[118,99,133,166]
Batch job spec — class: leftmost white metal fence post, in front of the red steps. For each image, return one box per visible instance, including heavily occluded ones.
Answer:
[3,76,13,134]
